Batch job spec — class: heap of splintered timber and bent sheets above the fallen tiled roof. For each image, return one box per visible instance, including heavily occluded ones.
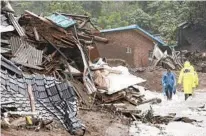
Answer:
[1,7,108,94]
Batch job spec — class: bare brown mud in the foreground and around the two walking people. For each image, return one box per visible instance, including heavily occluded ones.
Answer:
[1,69,206,136]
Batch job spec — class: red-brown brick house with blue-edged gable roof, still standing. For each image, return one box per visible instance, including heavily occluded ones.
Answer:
[91,25,165,67]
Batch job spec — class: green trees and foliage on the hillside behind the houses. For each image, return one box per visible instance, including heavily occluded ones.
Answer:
[11,1,206,44]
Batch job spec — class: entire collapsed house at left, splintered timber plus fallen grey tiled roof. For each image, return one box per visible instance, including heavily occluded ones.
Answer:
[1,1,110,134]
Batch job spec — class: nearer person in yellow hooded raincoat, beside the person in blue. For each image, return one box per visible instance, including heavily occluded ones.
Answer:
[178,61,194,100]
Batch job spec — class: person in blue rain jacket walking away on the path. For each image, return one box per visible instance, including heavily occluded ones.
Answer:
[162,69,176,100]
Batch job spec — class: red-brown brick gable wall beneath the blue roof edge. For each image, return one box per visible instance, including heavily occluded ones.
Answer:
[97,30,154,67]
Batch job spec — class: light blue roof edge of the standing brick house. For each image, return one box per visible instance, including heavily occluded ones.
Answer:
[100,25,166,45]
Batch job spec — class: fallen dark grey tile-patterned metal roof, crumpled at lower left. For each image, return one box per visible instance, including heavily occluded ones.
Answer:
[0,69,85,133]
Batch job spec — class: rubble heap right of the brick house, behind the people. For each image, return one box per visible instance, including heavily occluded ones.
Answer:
[150,45,206,73]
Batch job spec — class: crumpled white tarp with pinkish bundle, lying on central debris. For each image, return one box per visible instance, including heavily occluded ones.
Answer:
[91,59,146,94]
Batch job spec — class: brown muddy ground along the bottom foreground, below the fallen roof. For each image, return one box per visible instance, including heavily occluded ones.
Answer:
[1,110,129,136]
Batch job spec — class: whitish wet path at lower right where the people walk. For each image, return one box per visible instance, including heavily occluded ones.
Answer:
[129,90,206,136]
